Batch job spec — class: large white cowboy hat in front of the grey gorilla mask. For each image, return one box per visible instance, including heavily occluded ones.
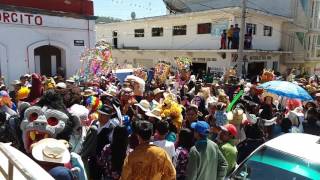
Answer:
[32,138,70,164]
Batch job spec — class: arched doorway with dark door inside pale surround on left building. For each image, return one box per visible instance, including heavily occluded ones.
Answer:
[28,40,70,76]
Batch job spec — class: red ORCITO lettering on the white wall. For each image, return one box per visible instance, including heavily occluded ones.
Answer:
[0,11,43,26]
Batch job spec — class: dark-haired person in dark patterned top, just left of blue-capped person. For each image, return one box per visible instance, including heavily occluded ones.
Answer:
[176,128,194,180]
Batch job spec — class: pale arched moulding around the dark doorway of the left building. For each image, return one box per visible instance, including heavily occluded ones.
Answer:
[27,40,71,76]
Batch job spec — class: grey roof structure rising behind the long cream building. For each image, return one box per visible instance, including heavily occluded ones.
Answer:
[163,0,292,18]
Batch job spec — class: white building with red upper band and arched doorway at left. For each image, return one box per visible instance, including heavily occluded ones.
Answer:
[0,0,96,82]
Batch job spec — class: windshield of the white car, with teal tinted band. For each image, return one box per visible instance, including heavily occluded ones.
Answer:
[231,146,320,180]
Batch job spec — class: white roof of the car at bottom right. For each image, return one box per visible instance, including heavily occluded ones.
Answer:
[265,133,320,163]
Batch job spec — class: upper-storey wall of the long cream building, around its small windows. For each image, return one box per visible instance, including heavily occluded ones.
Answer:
[97,11,283,50]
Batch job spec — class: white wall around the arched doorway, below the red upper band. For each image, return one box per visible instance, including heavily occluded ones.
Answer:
[0,11,95,81]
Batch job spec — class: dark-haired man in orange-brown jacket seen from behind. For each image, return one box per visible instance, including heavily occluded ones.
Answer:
[120,121,176,180]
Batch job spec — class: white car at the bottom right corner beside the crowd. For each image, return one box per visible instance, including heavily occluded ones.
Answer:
[229,133,320,180]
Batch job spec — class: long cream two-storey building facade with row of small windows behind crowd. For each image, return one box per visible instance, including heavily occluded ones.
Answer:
[96,7,291,76]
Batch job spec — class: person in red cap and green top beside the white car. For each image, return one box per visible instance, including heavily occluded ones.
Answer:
[219,124,238,174]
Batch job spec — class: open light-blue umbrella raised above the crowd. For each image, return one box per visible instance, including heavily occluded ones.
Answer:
[258,81,313,101]
